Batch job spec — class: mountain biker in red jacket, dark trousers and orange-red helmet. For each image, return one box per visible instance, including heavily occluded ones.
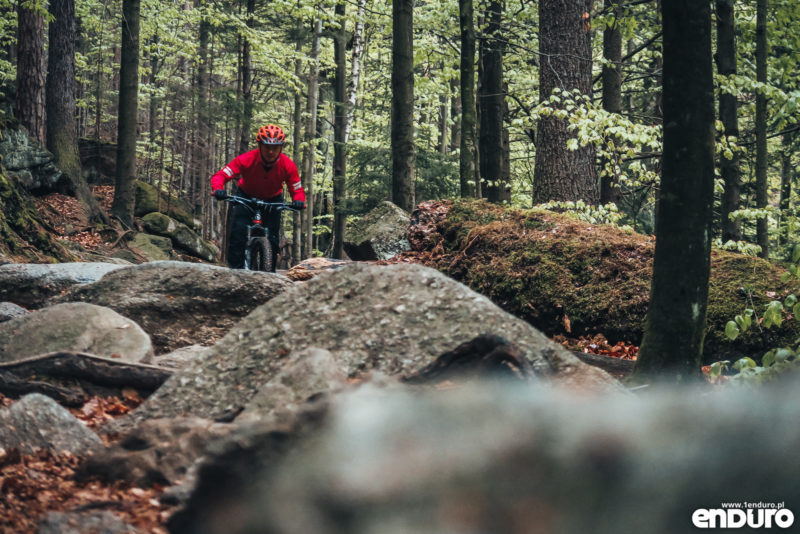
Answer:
[211,124,306,271]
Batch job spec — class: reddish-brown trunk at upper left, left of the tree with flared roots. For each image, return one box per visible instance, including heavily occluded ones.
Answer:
[17,2,45,144]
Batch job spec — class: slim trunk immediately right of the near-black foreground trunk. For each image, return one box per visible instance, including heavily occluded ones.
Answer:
[715,0,742,242]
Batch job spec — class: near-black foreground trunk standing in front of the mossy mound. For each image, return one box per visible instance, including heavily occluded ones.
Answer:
[634,0,714,382]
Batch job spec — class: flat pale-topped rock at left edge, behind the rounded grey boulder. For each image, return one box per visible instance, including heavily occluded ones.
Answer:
[0,263,122,309]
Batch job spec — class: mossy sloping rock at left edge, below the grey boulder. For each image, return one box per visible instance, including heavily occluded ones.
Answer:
[0,172,74,263]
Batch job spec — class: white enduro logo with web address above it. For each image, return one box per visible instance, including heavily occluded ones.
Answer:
[692,502,794,528]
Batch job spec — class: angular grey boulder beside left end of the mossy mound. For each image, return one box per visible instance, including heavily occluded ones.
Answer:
[344,201,411,260]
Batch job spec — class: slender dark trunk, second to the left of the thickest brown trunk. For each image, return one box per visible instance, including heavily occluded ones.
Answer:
[458,0,480,198]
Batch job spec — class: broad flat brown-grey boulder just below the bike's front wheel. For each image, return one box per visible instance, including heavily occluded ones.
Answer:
[59,261,292,354]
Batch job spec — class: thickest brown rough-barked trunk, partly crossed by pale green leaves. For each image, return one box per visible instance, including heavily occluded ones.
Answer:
[533,0,600,204]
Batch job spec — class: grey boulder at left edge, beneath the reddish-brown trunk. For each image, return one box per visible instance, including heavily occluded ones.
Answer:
[0,127,63,193]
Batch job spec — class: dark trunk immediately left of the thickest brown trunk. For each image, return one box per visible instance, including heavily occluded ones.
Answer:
[478,0,511,202]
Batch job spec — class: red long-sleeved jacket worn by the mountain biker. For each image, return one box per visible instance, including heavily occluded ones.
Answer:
[211,149,306,202]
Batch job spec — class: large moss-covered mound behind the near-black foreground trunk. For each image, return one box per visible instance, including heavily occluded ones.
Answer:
[416,201,800,361]
